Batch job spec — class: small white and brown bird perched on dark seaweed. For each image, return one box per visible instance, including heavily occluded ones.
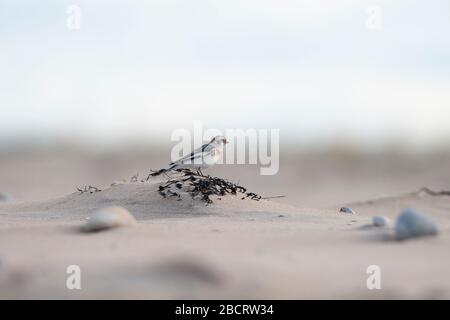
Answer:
[150,136,228,176]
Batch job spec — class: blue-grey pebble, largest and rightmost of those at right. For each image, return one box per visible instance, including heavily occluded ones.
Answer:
[395,209,438,240]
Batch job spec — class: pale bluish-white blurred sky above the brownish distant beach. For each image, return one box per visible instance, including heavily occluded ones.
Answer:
[0,0,450,149]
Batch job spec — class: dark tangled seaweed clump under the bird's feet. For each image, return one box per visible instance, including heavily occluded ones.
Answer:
[158,169,262,204]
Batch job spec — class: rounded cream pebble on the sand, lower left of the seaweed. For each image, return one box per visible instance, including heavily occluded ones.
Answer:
[82,207,137,232]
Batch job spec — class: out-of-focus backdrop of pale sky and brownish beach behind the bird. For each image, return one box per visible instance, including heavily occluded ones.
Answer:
[0,0,450,207]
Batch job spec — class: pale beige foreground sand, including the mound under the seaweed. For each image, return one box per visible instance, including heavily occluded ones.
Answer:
[0,169,450,299]
